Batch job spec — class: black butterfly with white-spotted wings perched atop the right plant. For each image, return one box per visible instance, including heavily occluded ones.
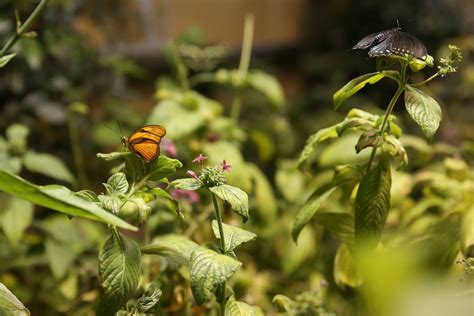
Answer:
[352,27,428,60]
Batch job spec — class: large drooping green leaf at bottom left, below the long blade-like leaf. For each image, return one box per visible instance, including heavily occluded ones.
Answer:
[97,229,141,315]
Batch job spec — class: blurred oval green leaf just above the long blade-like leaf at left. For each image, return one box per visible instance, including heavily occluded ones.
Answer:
[23,150,75,183]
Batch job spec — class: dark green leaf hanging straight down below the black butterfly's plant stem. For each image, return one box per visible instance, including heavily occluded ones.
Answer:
[354,156,392,247]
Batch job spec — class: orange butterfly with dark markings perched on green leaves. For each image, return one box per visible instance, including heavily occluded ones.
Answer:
[122,125,166,161]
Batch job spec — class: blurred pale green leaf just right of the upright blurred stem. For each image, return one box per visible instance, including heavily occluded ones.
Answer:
[246,70,285,107]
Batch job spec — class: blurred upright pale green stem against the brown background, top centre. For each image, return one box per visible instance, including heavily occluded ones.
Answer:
[231,14,254,121]
